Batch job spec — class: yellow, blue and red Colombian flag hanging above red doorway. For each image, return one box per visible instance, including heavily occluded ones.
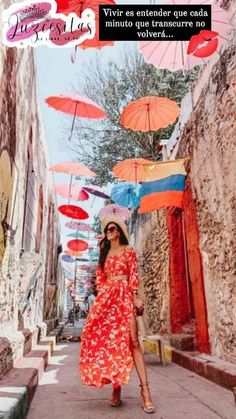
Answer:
[139,159,186,214]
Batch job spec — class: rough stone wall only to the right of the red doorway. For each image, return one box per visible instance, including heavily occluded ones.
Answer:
[176,37,236,362]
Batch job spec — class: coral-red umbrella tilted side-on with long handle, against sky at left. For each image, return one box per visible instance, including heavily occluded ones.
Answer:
[45,94,106,140]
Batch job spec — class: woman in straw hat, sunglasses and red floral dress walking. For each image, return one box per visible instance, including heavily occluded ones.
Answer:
[80,216,155,413]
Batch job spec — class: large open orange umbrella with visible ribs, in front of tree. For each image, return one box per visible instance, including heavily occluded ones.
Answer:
[120,96,180,132]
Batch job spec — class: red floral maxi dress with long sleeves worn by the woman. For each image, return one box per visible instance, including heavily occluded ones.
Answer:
[80,248,138,387]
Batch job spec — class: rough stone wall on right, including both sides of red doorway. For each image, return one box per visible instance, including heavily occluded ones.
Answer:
[132,1,236,362]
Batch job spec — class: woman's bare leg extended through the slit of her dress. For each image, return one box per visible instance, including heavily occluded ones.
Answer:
[130,314,153,407]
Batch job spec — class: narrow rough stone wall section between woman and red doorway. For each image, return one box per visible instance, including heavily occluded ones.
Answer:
[130,211,170,333]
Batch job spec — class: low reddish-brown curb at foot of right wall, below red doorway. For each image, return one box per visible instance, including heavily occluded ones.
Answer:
[144,339,236,390]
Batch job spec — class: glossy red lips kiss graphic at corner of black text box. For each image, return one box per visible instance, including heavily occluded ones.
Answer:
[187,30,219,58]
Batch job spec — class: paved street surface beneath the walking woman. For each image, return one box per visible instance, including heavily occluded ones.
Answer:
[28,326,236,419]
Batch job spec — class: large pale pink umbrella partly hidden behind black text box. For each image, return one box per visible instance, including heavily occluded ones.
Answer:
[138,0,230,71]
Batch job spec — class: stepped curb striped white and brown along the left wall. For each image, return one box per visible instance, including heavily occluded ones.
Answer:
[0,325,63,419]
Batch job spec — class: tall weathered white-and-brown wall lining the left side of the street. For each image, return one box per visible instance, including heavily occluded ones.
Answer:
[0,1,62,373]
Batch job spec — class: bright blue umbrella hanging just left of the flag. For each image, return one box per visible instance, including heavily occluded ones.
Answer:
[111,182,141,208]
